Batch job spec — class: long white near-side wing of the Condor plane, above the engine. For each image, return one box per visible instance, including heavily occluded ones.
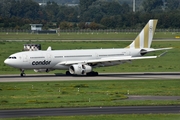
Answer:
[59,56,157,65]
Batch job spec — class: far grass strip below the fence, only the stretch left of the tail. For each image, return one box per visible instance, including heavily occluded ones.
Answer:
[0,33,137,40]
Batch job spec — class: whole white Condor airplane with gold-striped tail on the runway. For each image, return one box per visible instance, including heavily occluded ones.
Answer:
[4,19,172,76]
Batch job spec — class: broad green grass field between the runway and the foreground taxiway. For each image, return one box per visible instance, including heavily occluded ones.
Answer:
[0,80,180,109]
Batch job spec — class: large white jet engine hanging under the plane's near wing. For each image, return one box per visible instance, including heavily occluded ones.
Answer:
[69,64,92,75]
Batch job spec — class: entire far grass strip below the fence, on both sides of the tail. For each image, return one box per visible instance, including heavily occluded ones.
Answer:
[0,32,180,40]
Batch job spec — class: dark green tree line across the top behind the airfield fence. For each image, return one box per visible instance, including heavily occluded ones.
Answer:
[0,0,180,29]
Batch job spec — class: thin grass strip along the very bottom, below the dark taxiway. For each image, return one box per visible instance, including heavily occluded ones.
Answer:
[3,114,180,120]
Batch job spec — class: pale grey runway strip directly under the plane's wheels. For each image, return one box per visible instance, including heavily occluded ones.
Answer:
[0,72,180,82]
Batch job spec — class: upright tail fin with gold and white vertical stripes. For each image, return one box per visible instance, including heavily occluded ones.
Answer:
[126,20,158,48]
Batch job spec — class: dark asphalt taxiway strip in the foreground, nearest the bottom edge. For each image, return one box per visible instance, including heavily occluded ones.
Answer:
[0,106,180,118]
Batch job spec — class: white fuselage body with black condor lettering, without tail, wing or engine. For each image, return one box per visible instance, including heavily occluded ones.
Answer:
[5,48,141,70]
